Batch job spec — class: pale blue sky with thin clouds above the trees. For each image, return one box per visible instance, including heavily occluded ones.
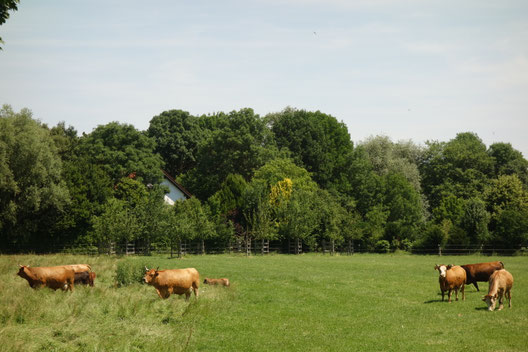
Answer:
[0,0,528,158]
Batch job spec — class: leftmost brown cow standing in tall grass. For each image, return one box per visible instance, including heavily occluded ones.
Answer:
[17,265,75,292]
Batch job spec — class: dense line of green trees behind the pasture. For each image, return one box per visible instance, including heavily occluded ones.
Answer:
[0,105,528,252]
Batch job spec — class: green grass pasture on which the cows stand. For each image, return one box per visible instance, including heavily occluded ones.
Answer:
[0,254,528,352]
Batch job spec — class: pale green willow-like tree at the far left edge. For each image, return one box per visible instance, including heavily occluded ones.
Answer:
[0,105,69,250]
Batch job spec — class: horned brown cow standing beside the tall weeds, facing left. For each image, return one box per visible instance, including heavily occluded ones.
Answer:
[143,267,200,301]
